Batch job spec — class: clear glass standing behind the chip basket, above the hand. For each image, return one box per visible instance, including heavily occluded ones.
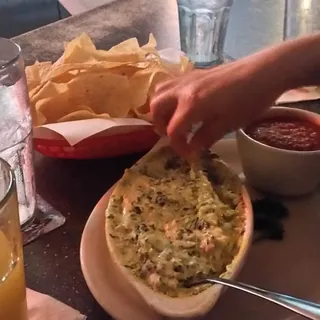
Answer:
[177,0,233,68]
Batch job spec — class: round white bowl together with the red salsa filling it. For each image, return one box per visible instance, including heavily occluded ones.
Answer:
[237,107,320,196]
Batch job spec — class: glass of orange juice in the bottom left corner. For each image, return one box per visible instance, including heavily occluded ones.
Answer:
[0,159,28,320]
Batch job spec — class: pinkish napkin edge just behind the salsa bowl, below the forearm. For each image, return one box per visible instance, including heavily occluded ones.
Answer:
[276,87,320,104]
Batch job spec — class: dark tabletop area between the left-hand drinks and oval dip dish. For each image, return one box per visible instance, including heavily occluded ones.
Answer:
[30,154,145,320]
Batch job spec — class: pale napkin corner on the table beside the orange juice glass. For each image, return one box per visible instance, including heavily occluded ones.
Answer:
[27,289,86,320]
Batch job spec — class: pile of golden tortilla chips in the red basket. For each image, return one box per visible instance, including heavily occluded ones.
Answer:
[26,33,190,125]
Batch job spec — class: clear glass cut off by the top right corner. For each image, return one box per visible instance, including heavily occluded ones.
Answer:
[283,0,320,40]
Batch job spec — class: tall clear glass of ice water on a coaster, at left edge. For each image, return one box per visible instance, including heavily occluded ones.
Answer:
[0,38,36,225]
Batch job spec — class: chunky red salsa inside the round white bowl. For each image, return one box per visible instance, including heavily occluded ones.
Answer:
[245,117,320,151]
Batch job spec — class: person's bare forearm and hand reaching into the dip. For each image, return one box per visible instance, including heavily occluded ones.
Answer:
[150,34,320,154]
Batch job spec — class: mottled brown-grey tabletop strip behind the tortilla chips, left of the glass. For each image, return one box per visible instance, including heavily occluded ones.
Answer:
[13,0,179,64]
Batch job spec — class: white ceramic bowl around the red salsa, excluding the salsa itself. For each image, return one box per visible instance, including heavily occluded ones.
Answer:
[237,107,320,196]
